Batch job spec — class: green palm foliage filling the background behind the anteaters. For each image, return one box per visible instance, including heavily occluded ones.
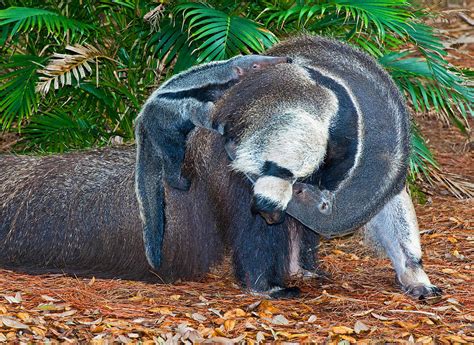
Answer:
[0,0,473,196]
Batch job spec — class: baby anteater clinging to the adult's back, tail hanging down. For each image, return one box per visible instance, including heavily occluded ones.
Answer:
[135,55,289,269]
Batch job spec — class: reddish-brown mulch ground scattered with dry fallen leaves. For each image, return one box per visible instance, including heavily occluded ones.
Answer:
[0,8,474,344]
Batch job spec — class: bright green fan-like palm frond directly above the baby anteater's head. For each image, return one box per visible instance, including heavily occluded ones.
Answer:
[174,3,278,63]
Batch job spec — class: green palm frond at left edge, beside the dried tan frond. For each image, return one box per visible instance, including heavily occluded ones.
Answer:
[0,55,46,130]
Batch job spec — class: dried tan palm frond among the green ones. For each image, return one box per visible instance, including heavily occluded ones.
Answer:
[36,44,112,95]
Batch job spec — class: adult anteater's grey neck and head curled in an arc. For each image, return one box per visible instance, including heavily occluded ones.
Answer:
[254,36,410,237]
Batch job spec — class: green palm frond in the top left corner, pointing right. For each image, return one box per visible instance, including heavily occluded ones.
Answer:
[0,7,93,36]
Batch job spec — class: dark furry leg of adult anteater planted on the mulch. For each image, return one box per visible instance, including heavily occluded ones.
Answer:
[233,216,300,298]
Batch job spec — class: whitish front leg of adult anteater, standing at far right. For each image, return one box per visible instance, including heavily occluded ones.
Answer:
[365,189,441,299]
